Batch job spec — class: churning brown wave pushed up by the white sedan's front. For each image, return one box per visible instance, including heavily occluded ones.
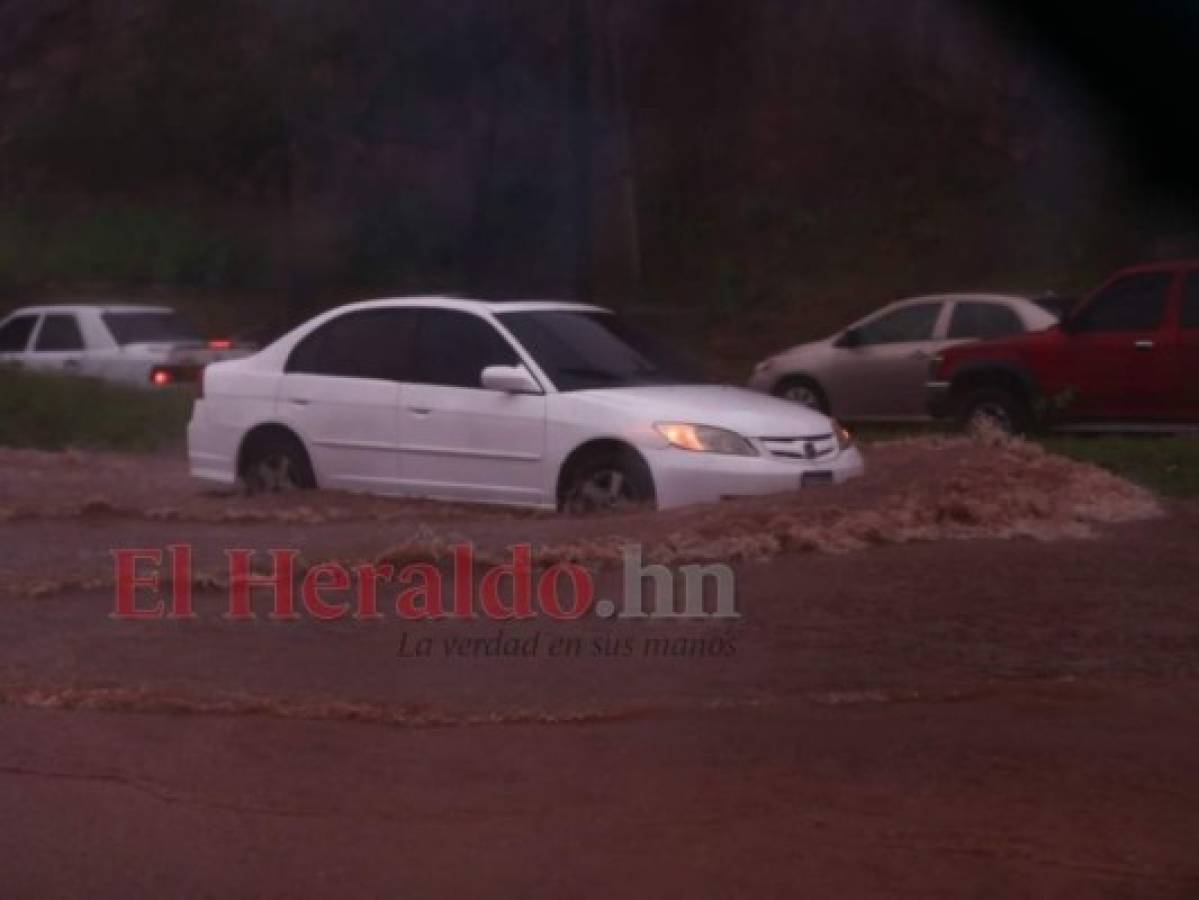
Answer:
[371,437,1163,564]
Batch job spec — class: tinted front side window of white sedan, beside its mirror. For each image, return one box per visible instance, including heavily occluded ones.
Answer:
[415,309,520,387]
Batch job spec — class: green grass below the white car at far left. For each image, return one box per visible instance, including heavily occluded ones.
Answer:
[0,368,192,451]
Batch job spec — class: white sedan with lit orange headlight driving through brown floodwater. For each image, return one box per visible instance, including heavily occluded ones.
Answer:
[188,297,862,513]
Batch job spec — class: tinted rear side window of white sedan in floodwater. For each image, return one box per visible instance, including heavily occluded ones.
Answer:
[285,309,420,381]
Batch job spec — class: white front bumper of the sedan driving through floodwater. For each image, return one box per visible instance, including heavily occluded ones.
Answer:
[643,447,866,509]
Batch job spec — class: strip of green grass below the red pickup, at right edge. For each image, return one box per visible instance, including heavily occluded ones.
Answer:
[1041,435,1199,497]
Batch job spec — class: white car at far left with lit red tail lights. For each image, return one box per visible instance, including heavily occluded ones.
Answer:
[0,303,253,387]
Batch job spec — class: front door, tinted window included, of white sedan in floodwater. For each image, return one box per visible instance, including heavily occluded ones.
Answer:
[399,308,547,503]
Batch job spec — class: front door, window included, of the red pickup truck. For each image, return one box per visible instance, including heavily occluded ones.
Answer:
[1061,272,1181,421]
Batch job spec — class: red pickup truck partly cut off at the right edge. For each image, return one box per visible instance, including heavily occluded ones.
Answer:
[927,260,1199,433]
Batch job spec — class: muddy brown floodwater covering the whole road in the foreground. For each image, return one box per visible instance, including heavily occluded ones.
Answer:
[0,439,1199,898]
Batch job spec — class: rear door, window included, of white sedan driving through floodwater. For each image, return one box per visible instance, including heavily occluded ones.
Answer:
[276,308,418,494]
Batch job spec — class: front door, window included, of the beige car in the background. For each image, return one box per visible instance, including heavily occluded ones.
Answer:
[829,300,945,419]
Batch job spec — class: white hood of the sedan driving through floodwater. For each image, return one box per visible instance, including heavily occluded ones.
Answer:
[567,385,832,437]
